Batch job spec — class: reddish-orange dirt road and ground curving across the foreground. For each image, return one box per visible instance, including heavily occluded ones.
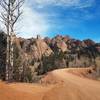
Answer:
[0,69,100,100]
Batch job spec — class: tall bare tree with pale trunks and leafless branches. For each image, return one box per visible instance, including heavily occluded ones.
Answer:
[0,0,24,81]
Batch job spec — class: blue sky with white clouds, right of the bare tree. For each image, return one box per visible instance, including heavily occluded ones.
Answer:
[0,0,100,42]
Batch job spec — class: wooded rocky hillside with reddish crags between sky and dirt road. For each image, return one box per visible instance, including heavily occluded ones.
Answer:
[0,33,100,81]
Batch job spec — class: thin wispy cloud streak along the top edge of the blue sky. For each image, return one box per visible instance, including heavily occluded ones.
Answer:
[31,0,94,8]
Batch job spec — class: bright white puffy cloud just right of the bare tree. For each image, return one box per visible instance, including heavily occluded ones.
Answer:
[0,0,48,38]
